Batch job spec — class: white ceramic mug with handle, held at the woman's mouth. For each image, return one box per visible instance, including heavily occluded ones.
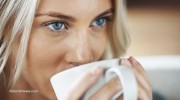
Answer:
[50,59,138,100]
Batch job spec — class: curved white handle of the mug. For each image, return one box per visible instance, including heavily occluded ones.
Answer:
[105,66,138,100]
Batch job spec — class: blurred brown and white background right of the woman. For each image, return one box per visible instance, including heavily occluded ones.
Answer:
[126,0,180,100]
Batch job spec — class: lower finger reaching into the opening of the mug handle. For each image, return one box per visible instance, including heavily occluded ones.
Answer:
[90,77,122,100]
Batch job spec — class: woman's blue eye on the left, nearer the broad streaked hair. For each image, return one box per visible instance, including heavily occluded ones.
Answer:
[46,22,65,31]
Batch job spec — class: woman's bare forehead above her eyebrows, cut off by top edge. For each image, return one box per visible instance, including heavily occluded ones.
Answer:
[37,0,112,18]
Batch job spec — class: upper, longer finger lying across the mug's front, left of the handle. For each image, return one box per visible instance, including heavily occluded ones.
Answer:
[64,67,103,100]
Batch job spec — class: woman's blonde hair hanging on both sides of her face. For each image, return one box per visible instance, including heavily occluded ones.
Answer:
[0,0,129,87]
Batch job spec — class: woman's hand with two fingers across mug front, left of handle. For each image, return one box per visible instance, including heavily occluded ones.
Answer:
[63,67,122,100]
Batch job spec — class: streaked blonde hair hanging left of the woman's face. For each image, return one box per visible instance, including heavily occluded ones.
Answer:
[0,0,37,87]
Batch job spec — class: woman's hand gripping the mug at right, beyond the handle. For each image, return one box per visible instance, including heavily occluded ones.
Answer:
[120,57,152,100]
